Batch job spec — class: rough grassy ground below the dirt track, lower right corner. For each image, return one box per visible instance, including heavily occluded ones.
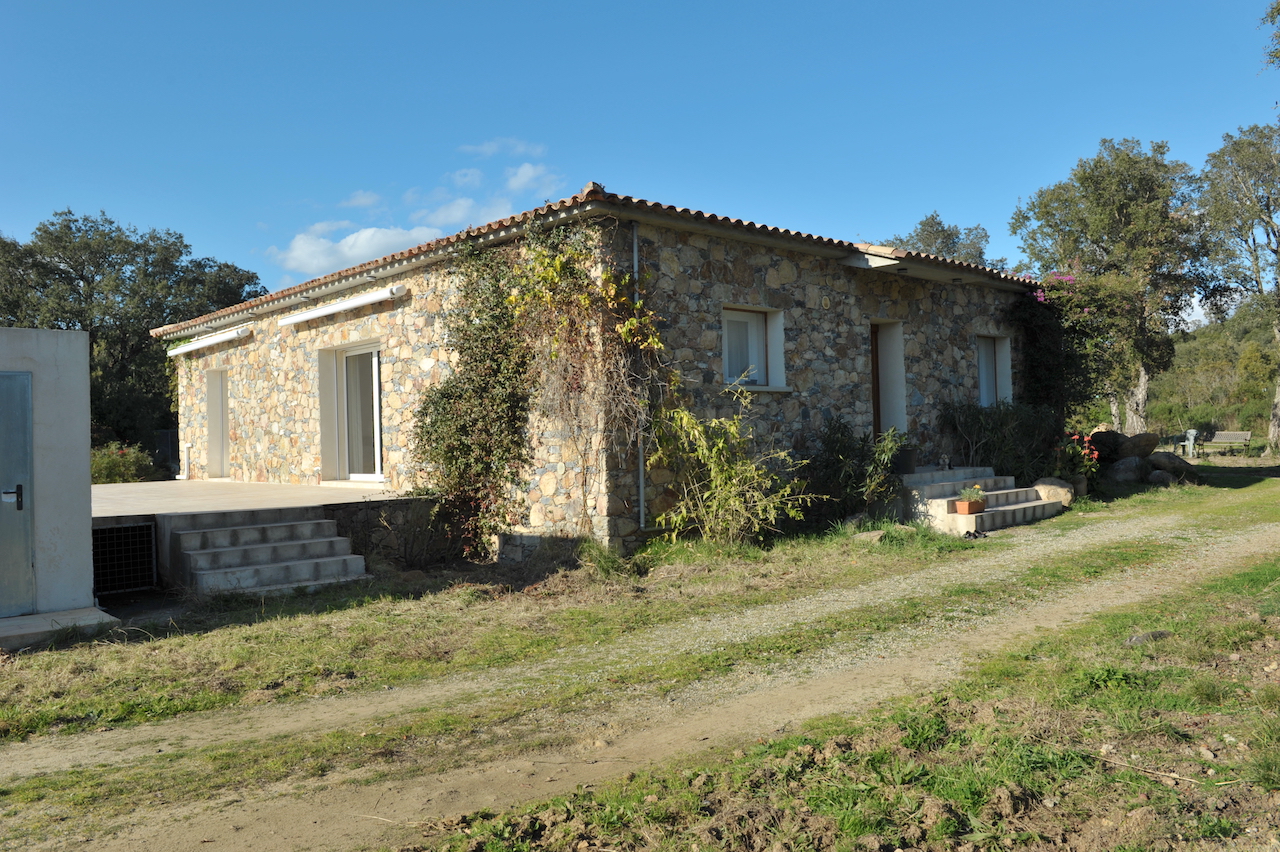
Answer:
[426,544,1280,849]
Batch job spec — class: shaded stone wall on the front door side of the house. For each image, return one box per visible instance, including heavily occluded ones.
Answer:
[599,225,1018,545]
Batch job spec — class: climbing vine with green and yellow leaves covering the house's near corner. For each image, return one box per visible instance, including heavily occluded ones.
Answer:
[413,225,669,554]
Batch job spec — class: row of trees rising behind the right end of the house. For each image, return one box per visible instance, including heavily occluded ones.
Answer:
[886,124,1280,445]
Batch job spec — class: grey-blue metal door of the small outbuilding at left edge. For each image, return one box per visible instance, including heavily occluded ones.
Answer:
[0,372,36,618]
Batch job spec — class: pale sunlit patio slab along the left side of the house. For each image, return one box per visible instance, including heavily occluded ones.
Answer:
[92,480,397,518]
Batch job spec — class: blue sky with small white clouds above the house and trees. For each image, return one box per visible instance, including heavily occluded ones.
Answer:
[0,0,1280,289]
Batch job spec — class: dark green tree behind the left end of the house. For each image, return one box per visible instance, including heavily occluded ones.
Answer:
[0,210,266,445]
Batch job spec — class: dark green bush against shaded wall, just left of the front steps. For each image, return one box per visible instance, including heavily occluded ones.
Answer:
[810,417,906,518]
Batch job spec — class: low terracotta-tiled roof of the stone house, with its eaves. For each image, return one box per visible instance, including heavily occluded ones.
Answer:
[151,182,1034,339]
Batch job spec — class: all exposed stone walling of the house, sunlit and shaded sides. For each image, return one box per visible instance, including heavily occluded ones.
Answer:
[177,216,1016,558]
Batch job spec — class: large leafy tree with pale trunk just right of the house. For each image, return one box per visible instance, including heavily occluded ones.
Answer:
[1010,139,1213,434]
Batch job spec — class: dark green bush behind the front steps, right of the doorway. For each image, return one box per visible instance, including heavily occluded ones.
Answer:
[941,402,1062,487]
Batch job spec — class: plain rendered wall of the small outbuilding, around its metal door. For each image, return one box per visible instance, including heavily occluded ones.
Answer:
[0,327,93,613]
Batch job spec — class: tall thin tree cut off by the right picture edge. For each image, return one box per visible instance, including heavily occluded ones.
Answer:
[1201,122,1280,448]
